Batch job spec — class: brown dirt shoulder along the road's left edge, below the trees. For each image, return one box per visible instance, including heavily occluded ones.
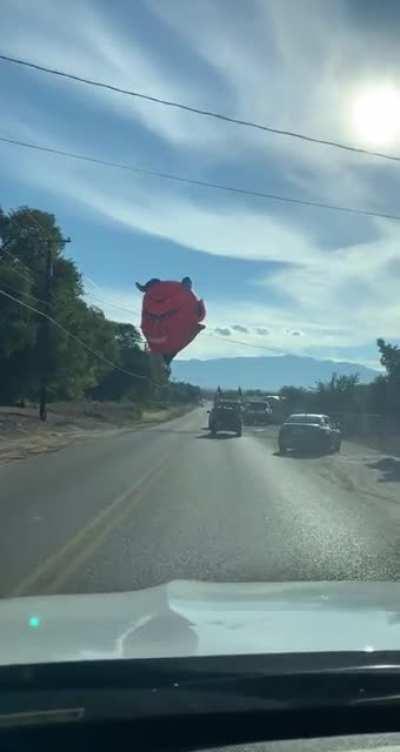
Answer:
[0,402,191,464]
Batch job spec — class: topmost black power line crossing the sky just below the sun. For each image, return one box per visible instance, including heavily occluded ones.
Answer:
[0,54,400,167]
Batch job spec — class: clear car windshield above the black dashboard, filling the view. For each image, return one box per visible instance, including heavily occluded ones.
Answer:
[0,0,400,667]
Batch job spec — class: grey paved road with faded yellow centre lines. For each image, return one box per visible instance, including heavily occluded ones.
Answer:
[0,410,400,596]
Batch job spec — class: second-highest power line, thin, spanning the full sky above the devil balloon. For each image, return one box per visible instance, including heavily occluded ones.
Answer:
[0,136,400,221]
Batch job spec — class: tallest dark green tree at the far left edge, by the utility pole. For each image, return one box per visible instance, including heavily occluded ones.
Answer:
[0,207,72,400]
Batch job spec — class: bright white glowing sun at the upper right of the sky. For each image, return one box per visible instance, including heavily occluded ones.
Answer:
[352,86,400,146]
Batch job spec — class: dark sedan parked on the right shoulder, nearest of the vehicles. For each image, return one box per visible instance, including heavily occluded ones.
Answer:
[279,413,342,454]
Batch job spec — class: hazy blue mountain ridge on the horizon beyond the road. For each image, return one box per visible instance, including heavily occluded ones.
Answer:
[172,355,379,391]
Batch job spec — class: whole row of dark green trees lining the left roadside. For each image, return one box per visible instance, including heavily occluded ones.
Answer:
[0,207,200,419]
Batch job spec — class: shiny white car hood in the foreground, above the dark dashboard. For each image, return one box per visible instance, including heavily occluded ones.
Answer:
[0,581,400,665]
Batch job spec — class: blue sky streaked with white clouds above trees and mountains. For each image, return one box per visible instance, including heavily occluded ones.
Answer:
[0,0,400,364]
